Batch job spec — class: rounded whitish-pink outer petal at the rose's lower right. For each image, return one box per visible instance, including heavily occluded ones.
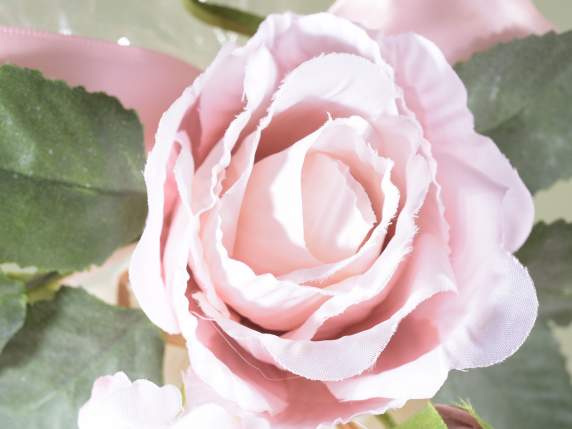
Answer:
[442,251,538,369]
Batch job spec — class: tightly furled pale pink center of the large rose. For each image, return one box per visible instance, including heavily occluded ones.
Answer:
[233,136,376,275]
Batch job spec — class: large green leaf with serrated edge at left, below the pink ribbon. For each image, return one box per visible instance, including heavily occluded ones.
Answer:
[0,65,146,272]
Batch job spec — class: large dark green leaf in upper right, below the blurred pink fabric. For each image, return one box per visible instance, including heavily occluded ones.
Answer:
[456,32,572,192]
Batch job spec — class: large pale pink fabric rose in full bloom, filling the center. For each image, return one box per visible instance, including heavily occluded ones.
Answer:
[130,13,537,429]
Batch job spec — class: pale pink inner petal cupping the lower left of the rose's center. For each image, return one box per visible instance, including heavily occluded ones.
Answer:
[200,126,338,330]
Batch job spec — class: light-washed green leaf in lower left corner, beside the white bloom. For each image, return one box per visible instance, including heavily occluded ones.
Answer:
[0,288,163,429]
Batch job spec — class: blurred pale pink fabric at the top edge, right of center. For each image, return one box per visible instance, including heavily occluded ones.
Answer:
[330,0,552,63]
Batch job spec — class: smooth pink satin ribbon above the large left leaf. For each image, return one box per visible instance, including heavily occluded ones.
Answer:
[0,27,200,150]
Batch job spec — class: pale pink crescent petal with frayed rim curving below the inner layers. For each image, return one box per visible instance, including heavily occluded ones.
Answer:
[195,227,454,381]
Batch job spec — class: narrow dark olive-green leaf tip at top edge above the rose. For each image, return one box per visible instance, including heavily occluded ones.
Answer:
[183,0,264,36]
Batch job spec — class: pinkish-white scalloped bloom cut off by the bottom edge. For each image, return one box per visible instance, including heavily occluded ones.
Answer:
[78,372,269,429]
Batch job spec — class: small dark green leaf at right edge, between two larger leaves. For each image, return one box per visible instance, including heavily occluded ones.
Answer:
[517,220,572,325]
